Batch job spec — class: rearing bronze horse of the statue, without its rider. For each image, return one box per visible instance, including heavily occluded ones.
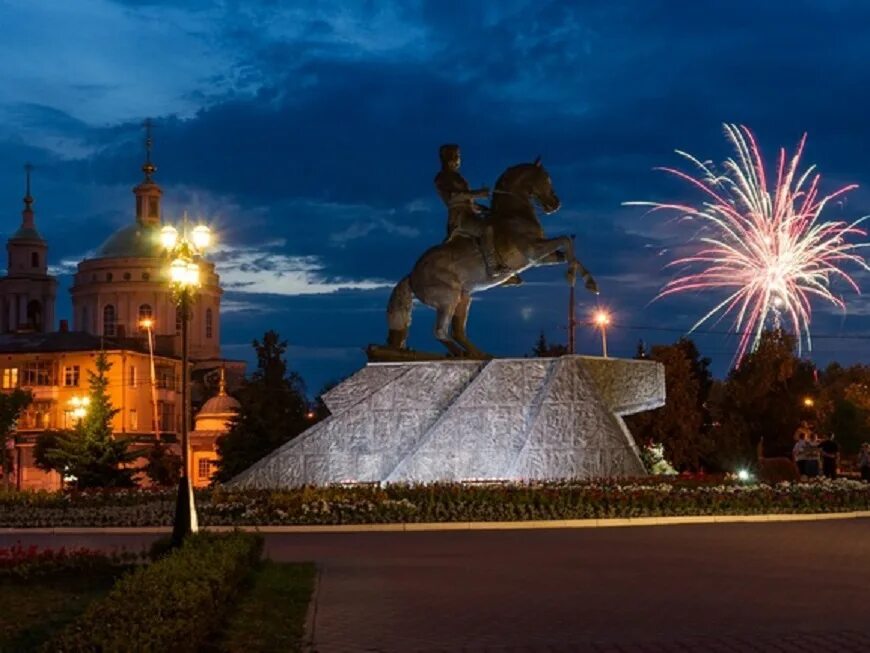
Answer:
[369,158,598,358]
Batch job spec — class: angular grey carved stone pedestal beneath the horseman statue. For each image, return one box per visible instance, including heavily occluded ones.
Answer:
[231,356,665,488]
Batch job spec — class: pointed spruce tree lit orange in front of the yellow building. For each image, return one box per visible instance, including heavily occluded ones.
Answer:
[34,351,137,489]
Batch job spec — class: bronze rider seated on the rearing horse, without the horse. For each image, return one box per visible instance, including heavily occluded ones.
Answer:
[435,144,522,285]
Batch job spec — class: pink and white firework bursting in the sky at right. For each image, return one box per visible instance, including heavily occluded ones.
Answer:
[627,125,870,362]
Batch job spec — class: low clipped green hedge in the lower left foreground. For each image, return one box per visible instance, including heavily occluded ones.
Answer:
[45,532,263,653]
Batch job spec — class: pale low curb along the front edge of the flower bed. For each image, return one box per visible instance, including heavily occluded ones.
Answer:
[0,510,870,535]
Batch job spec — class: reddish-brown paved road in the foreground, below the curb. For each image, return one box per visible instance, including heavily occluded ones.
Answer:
[6,520,870,653]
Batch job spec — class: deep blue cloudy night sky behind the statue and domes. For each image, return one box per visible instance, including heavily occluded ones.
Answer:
[0,0,870,393]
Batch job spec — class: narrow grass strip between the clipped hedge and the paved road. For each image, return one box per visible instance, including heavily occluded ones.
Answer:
[209,560,315,653]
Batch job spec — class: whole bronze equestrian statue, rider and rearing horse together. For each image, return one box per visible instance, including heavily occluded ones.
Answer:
[368,144,598,361]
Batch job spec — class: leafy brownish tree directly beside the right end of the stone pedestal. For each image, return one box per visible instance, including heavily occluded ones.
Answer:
[626,339,709,471]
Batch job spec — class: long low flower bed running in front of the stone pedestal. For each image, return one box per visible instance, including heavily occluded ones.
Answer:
[0,478,870,528]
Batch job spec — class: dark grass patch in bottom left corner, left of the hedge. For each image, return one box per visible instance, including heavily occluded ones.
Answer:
[0,570,121,653]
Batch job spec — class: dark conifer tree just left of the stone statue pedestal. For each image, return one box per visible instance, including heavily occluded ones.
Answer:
[215,331,310,481]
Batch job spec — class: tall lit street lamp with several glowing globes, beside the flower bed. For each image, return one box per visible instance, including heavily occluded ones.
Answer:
[160,214,211,546]
